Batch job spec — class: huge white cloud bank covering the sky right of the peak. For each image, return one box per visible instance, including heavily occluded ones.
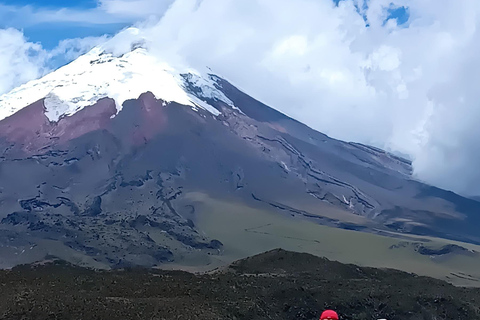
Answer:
[124,0,480,194]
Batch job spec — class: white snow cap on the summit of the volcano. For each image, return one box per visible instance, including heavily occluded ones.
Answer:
[0,28,235,122]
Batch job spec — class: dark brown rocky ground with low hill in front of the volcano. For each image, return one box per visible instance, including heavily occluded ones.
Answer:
[0,250,480,320]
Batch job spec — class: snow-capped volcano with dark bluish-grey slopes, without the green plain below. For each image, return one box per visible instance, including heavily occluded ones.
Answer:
[0,29,480,267]
